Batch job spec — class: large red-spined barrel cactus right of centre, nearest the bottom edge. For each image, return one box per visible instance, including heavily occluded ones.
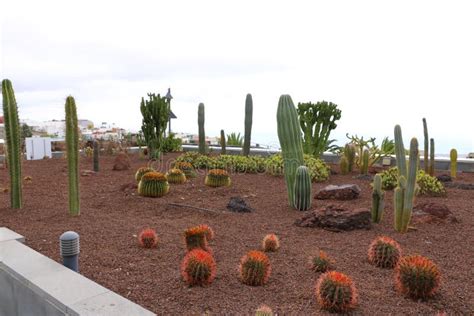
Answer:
[316,271,357,313]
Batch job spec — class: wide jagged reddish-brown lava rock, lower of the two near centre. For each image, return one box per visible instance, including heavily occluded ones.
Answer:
[295,205,371,232]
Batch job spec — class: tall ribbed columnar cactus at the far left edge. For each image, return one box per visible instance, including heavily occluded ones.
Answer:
[2,79,22,208]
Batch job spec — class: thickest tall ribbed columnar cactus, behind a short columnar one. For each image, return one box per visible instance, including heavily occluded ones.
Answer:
[277,95,304,206]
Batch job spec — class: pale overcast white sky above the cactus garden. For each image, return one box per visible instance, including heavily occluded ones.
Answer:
[0,0,474,153]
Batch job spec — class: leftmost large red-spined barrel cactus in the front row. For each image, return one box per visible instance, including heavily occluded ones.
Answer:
[181,249,216,286]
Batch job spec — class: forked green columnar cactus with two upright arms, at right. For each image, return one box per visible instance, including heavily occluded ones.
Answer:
[394,125,418,233]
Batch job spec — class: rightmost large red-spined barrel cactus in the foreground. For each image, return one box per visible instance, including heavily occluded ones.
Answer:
[395,255,441,299]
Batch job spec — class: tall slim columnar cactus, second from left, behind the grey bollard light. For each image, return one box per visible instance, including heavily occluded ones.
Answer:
[66,96,80,216]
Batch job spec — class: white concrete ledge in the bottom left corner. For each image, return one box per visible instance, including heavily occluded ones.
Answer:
[0,228,155,316]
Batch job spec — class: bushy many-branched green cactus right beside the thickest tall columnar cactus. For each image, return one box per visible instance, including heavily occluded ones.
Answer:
[297,101,341,157]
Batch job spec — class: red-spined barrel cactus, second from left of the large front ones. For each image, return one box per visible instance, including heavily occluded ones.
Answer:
[240,250,271,286]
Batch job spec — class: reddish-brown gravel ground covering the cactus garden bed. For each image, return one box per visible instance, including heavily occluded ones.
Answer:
[0,155,474,315]
